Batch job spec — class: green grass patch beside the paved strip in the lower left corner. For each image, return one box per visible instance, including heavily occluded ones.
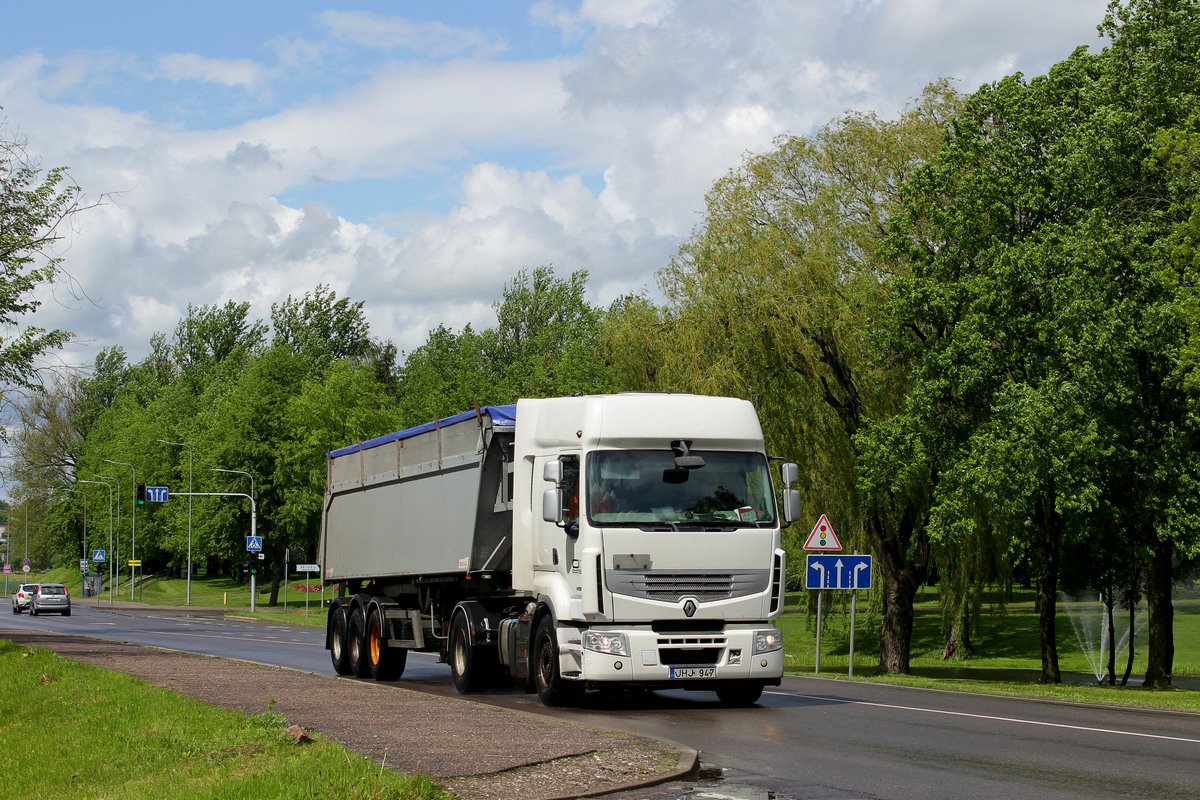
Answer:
[0,639,448,800]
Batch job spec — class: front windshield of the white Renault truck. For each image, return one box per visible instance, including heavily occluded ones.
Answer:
[586,450,775,530]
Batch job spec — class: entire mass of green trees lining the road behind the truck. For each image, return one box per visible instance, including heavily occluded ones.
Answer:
[7,0,1200,687]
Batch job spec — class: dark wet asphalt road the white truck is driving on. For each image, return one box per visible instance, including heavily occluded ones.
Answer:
[9,603,1200,800]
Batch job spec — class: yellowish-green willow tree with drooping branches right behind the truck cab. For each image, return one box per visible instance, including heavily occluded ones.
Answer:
[608,82,959,673]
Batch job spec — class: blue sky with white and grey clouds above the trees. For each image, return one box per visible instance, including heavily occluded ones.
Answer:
[0,0,1106,365]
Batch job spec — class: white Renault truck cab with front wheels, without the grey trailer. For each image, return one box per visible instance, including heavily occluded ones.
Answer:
[514,393,785,703]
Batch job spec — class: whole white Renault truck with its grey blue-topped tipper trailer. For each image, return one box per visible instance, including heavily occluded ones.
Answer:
[319,392,800,705]
